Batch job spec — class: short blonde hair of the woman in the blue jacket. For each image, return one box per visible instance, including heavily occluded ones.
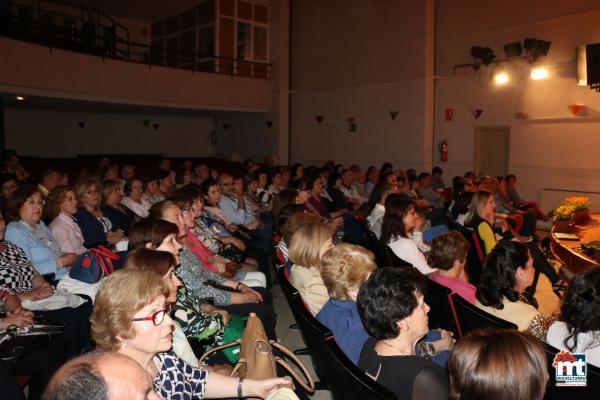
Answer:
[321,243,377,300]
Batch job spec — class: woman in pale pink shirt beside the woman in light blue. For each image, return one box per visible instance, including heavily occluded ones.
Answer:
[44,186,87,254]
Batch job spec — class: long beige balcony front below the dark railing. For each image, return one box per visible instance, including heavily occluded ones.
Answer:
[0,38,271,112]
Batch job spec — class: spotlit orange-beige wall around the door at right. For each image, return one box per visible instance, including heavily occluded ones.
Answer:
[434,0,600,199]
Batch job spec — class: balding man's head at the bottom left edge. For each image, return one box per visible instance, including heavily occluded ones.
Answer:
[43,352,160,400]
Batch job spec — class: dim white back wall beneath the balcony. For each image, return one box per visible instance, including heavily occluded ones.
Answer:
[4,108,213,157]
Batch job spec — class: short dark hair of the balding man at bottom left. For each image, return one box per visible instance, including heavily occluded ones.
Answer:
[42,356,108,400]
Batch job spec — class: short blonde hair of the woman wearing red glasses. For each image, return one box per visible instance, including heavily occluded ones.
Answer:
[91,268,169,351]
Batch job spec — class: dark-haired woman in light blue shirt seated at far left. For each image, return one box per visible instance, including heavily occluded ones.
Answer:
[6,185,77,280]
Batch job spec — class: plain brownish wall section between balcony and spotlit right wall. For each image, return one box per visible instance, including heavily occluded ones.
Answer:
[291,0,433,169]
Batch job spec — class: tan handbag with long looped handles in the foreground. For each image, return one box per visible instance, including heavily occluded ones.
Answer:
[200,313,315,394]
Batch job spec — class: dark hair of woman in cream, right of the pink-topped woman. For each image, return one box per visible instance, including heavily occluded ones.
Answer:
[476,242,529,310]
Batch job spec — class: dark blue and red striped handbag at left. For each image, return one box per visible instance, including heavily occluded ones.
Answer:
[69,246,121,283]
